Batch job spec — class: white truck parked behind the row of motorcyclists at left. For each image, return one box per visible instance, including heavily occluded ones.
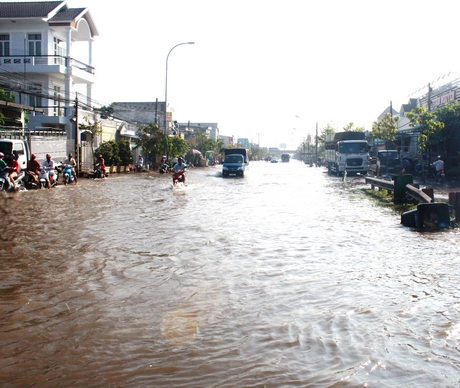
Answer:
[0,127,69,170]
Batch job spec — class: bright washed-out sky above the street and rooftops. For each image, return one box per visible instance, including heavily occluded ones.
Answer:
[64,0,460,146]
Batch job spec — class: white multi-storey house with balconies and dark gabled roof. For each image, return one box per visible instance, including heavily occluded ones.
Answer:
[0,1,98,152]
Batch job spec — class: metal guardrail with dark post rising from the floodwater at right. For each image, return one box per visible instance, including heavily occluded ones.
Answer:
[365,175,434,203]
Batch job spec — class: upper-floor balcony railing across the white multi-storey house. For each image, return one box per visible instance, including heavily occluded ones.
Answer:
[0,55,94,74]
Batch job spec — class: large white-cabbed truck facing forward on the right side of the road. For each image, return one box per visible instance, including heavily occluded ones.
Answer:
[326,131,369,176]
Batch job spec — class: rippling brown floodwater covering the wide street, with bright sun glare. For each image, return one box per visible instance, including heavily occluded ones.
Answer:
[0,161,460,388]
